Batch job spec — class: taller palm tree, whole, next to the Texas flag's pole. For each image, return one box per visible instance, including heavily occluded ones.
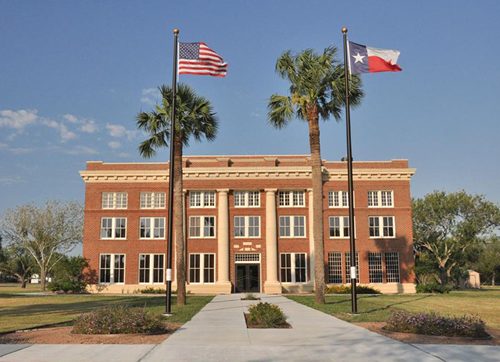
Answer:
[268,47,363,303]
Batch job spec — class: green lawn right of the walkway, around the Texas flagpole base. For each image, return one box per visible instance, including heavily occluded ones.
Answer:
[288,288,500,328]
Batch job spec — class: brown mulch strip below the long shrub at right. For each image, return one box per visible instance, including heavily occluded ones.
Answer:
[354,322,500,346]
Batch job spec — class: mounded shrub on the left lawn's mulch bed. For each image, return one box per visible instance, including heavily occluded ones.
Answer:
[72,305,166,334]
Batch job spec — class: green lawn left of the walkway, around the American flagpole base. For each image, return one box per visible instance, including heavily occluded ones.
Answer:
[0,285,213,333]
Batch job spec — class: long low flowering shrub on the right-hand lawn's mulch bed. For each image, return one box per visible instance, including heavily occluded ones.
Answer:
[384,311,488,338]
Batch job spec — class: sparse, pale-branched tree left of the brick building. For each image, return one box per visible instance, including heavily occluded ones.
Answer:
[2,201,83,290]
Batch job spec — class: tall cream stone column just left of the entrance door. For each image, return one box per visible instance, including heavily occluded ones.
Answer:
[216,189,231,293]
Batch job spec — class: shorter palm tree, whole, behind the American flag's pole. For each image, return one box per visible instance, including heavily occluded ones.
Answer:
[137,84,218,305]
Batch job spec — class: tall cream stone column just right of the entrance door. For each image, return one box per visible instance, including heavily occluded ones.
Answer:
[264,189,281,294]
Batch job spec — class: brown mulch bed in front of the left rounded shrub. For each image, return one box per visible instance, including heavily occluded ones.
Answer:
[0,323,181,344]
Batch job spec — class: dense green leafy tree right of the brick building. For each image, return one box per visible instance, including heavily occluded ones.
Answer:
[413,191,500,285]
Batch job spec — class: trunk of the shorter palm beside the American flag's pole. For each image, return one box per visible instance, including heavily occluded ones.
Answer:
[174,132,186,305]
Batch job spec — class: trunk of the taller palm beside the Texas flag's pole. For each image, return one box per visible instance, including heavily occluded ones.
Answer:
[307,104,325,304]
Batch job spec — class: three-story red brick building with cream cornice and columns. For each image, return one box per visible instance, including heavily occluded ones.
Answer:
[80,156,415,293]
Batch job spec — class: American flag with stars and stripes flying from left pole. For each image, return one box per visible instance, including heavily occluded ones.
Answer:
[178,43,227,77]
